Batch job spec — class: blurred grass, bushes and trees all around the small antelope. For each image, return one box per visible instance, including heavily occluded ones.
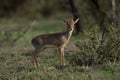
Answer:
[0,0,120,80]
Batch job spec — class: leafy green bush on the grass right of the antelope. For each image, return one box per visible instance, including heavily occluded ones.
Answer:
[70,25,120,66]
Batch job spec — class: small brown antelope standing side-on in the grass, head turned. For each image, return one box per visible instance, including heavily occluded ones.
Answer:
[31,18,79,68]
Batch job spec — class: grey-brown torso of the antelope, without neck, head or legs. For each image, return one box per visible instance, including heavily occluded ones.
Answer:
[32,32,68,48]
